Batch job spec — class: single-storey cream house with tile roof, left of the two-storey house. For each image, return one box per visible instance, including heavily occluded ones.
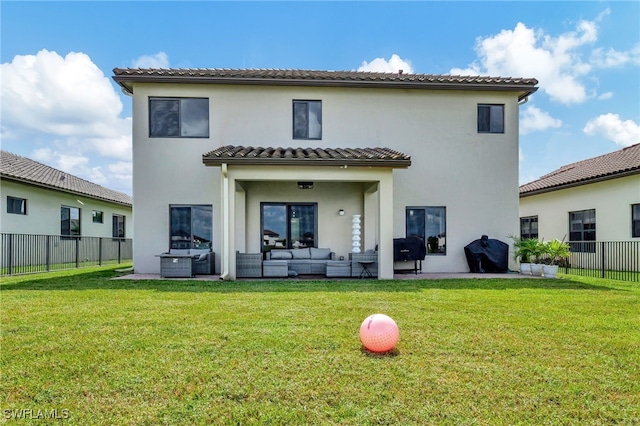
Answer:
[0,151,133,238]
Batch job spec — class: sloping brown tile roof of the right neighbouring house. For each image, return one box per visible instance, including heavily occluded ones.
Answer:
[520,143,640,197]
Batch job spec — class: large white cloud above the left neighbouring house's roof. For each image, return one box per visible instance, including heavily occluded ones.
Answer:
[1,50,131,188]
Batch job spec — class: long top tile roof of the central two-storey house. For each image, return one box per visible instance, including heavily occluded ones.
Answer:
[113,68,538,98]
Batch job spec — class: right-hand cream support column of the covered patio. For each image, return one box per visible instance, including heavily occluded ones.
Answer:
[378,173,393,280]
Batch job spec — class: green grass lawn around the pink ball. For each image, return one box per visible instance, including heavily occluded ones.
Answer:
[0,267,640,425]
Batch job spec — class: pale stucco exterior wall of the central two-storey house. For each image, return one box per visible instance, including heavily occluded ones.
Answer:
[133,84,519,273]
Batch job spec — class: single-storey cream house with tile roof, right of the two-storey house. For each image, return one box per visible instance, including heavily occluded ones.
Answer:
[520,144,640,248]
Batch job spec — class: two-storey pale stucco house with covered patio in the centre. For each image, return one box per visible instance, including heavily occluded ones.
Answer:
[114,69,537,279]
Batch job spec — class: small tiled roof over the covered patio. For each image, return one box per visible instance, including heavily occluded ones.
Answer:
[202,145,411,168]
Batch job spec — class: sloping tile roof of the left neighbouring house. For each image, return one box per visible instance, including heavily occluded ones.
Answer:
[0,150,133,206]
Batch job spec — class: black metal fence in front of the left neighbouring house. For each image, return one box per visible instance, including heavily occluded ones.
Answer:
[0,234,133,276]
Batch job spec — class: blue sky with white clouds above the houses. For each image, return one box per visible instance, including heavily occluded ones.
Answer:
[0,0,640,194]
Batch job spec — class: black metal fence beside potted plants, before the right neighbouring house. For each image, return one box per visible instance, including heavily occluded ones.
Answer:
[564,241,640,282]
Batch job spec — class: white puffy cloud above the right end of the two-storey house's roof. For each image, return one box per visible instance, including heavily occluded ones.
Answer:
[450,9,624,105]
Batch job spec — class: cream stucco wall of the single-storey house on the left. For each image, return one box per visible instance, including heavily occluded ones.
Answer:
[0,179,133,238]
